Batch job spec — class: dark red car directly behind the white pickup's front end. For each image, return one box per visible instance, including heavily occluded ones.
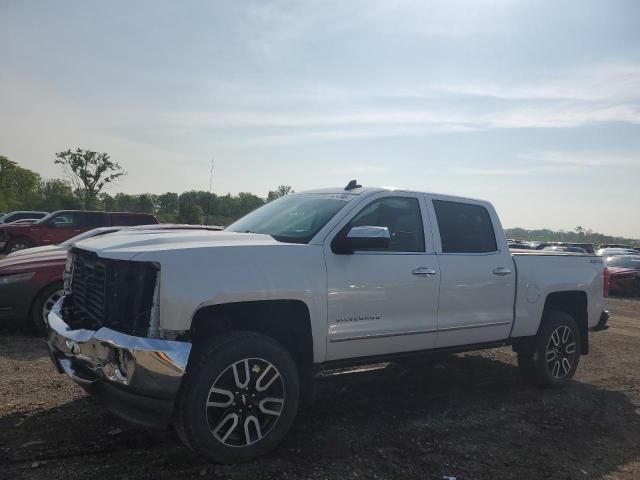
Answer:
[0,224,222,334]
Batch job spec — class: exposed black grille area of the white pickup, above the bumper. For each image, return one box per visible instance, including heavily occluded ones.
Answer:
[63,249,158,336]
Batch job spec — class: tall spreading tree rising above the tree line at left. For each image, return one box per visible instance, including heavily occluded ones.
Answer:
[54,148,127,208]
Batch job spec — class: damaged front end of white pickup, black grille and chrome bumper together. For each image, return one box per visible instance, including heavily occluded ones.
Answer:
[48,249,191,426]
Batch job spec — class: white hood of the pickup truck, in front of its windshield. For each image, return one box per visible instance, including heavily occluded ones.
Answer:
[75,230,282,260]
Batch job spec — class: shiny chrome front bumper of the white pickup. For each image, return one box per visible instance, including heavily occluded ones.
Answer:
[48,299,191,402]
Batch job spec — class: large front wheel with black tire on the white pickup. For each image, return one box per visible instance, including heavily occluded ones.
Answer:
[174,332,300,463]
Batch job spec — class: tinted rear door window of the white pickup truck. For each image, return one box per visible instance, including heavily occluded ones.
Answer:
[433,200,498,253]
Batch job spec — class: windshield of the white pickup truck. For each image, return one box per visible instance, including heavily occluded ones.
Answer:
[225,193,356,243]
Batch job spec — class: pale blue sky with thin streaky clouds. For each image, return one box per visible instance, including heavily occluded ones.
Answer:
[0,0,640,238]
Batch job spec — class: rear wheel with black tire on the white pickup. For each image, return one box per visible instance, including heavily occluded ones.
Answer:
[518,311,582,388]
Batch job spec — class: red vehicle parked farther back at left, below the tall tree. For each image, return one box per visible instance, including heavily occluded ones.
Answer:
[0,210,158,253]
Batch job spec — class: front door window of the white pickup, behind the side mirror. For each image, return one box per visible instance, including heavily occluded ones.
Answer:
[345,197,425,252]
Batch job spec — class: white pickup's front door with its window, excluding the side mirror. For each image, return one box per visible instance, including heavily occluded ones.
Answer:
[324,192,440,360]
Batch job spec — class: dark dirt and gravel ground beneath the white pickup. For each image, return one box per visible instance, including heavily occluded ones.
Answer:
[0,300,640,480]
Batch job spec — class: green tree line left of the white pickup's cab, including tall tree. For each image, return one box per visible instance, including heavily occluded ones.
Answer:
[0,149,293,225]
